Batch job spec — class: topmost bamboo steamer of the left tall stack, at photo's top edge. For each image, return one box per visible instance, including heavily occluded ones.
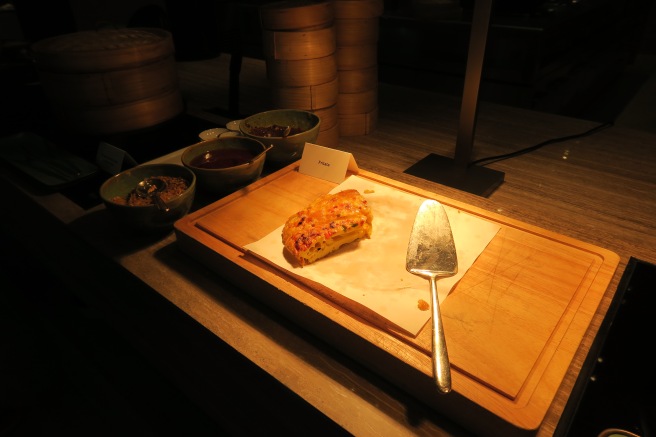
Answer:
[260,0,335,30]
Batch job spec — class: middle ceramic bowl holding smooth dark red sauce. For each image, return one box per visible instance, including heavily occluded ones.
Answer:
[181,136,268,194]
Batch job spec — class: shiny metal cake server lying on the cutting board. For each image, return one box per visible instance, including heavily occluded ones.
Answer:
[406,200,458,393]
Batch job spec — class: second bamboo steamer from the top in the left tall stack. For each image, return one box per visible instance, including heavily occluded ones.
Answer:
[262,25,336,61]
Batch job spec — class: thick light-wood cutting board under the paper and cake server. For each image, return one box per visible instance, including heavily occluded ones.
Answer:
[175,163,619,435]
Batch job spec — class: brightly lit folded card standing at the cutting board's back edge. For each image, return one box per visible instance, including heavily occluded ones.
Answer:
[298,143,359,184]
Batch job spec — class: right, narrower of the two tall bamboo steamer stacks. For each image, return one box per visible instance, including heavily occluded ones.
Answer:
[333,0,384,136]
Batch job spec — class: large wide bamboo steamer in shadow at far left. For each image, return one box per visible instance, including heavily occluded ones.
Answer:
[32,28,184,134]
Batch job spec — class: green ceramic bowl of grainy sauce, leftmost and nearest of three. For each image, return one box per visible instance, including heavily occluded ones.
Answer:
[100,164,196,232]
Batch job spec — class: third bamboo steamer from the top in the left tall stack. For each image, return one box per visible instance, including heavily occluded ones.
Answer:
[265,54,337,87]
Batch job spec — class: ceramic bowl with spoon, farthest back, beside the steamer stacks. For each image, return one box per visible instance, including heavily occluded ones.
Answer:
[239,109,321,163]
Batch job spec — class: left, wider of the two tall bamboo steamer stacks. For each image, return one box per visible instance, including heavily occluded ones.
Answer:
[260,0,339,147]
